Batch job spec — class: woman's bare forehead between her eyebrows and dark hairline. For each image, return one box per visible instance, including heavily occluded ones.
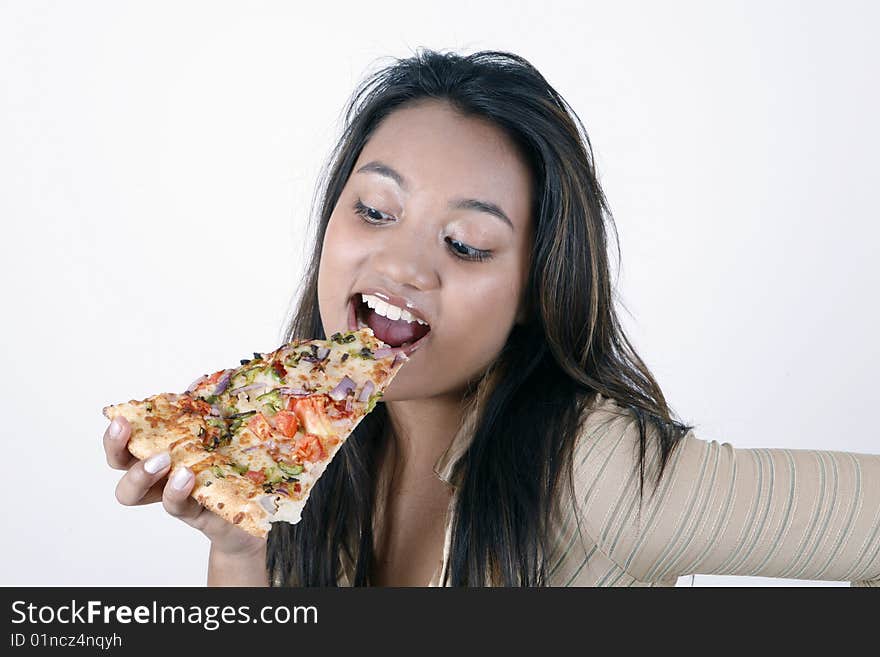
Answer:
[355,100,531,226]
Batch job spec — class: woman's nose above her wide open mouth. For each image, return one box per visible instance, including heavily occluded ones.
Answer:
[372,221,440,290]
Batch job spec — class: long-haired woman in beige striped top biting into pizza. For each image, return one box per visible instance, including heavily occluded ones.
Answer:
[104,51,880,586]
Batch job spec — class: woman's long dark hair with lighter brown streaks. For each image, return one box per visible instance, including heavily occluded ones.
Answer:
[267,49,692,586]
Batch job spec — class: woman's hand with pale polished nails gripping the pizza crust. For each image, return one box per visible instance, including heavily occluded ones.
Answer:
[104,416,266,559]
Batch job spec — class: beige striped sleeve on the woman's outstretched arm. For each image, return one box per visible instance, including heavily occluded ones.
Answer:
[574,398,880,586]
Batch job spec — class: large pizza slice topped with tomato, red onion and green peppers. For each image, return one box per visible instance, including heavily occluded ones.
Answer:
[104,327,409,537]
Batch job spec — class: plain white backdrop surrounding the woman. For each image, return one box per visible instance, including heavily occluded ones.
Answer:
[0,0,880,586]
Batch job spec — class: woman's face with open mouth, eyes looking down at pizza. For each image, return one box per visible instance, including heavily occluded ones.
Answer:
[318,100,532,401]
